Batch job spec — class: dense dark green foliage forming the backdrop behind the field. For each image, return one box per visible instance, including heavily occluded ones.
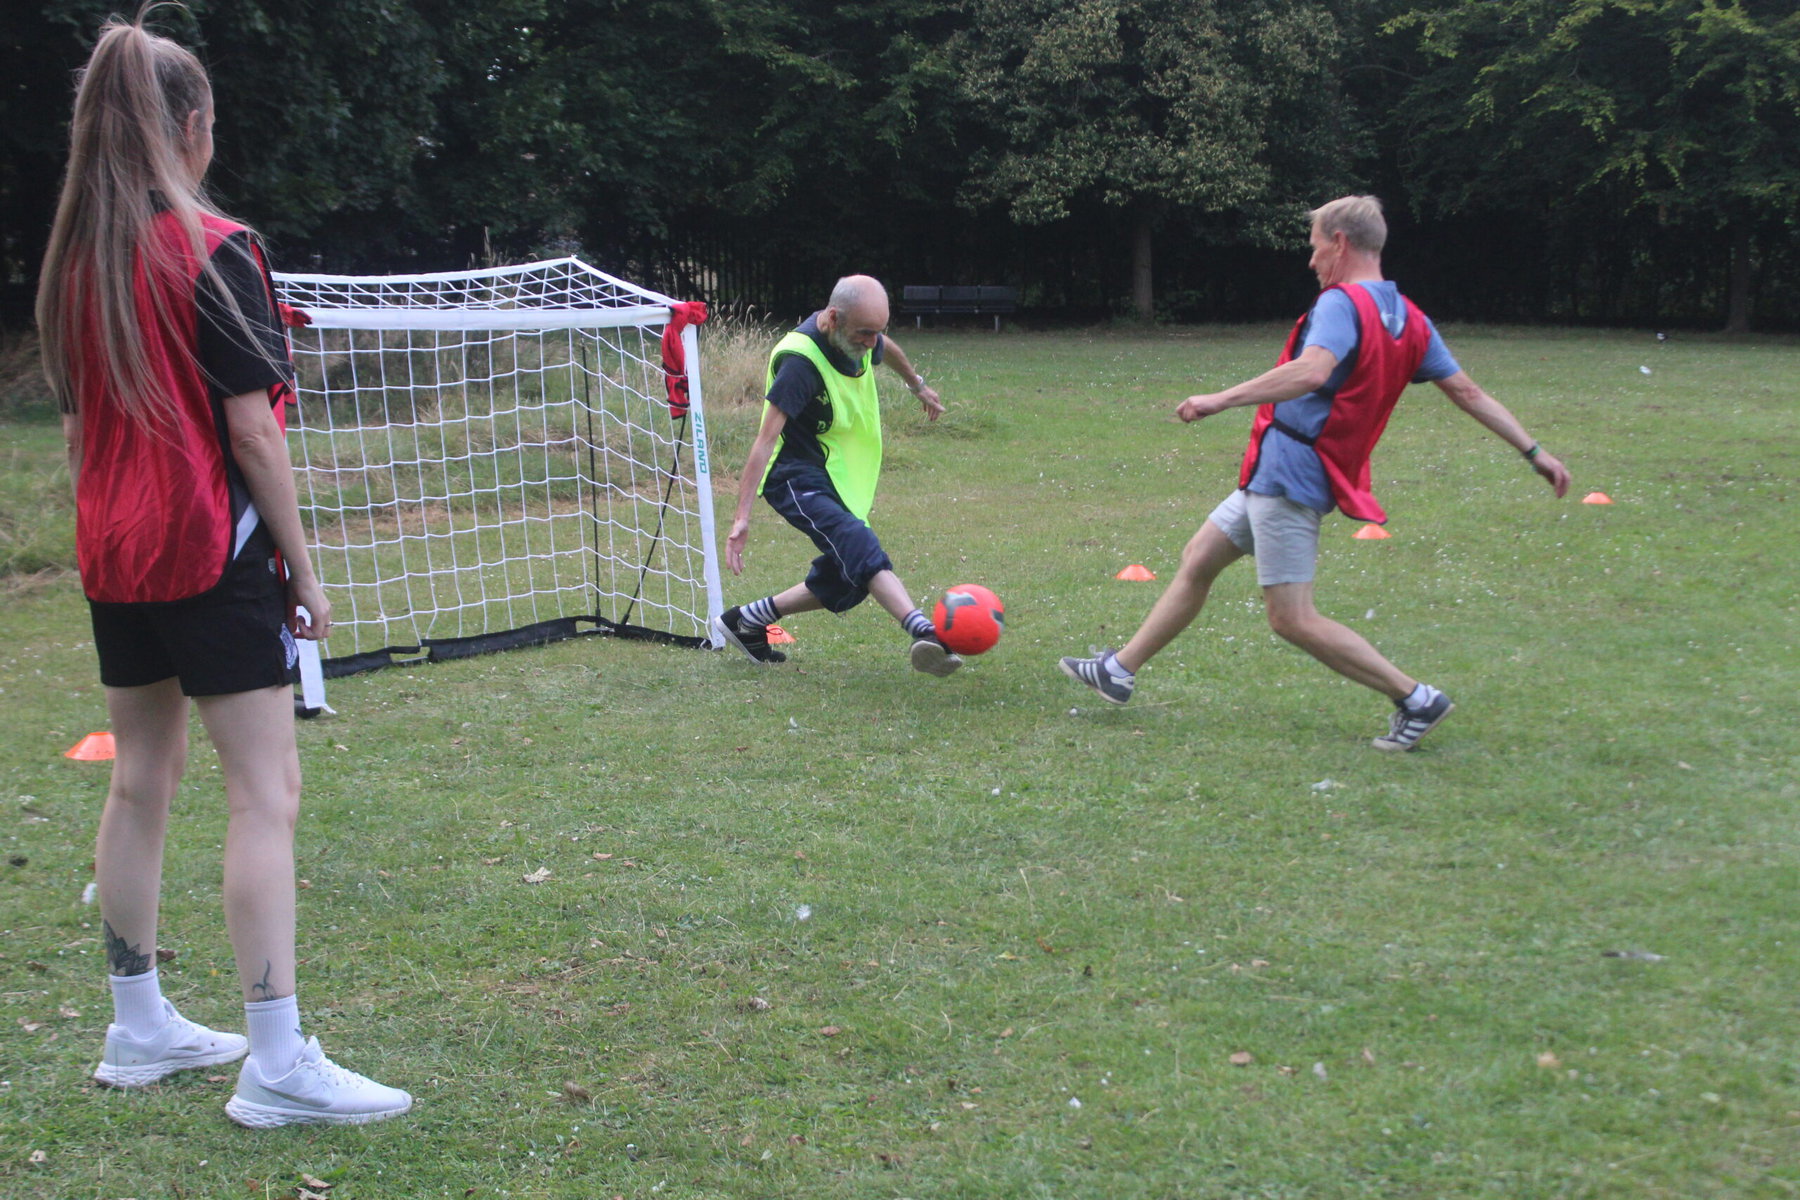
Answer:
[0,0,1800,327]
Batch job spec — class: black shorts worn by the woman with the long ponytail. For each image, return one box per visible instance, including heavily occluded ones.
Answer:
[88,527,299,696]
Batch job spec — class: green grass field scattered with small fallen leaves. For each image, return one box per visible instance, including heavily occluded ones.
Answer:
[0,326,1800,1200]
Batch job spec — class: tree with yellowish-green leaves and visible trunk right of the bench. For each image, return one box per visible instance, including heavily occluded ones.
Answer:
[956,0,1350,318]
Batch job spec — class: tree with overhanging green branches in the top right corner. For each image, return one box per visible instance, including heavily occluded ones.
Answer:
[1390,0,1800,329]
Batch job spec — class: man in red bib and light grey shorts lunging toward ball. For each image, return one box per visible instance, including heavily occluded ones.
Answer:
[1062,196,1570,750]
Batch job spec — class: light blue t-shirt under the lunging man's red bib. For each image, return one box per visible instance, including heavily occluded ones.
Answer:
[1249,279,1462,513]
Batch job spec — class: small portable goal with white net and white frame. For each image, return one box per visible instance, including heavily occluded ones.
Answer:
[275,259,720,676]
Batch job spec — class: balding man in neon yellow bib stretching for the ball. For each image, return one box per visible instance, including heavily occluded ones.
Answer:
[713,275,963,676]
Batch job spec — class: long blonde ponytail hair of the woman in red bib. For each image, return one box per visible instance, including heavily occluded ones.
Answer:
[38,4,243,426]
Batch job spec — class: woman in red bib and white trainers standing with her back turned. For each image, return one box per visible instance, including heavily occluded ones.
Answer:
[38,7,412,1128]
